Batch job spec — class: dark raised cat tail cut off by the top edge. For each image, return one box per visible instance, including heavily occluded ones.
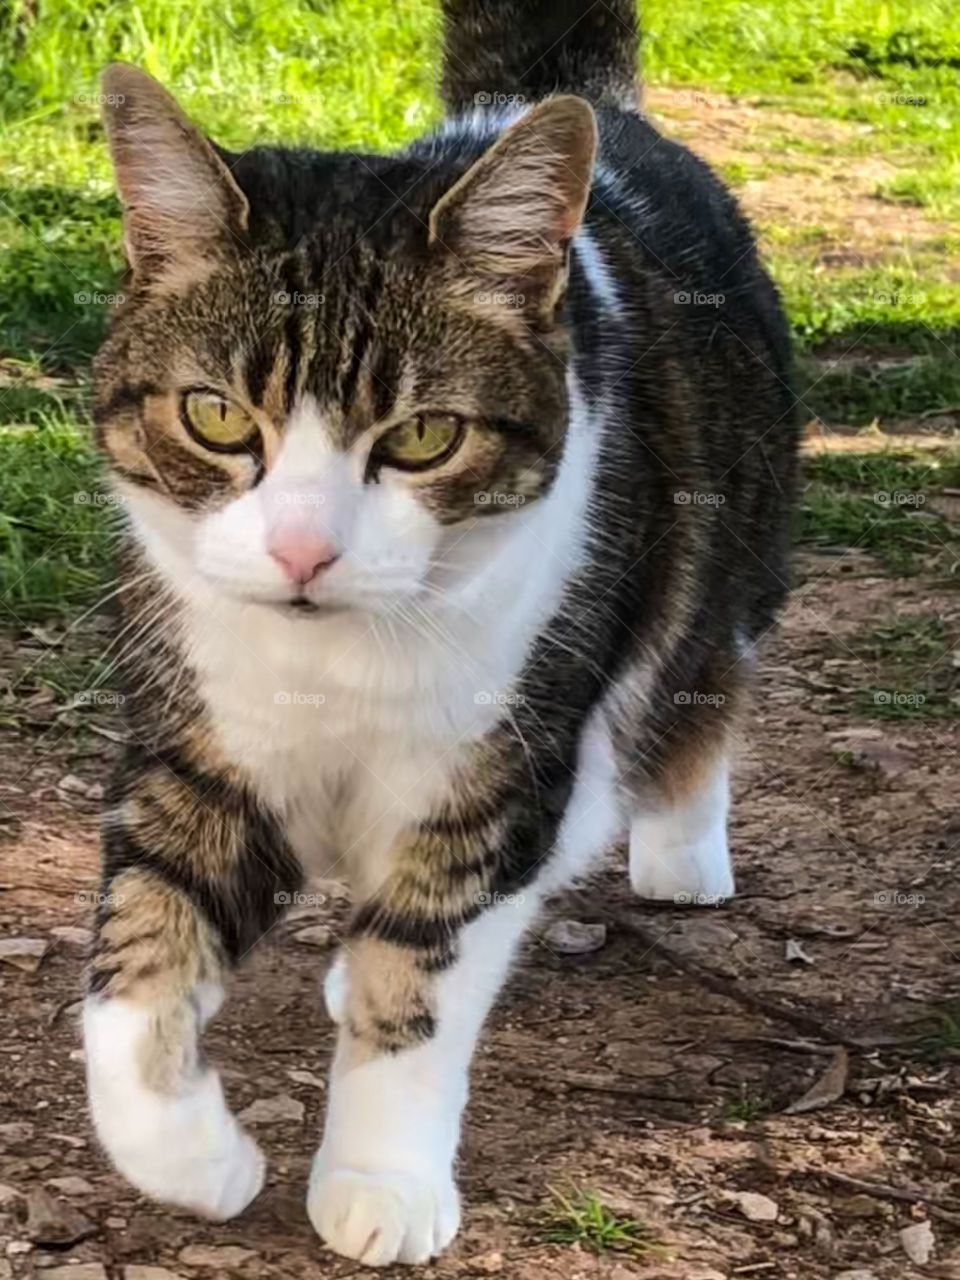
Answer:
[442,0,640,111]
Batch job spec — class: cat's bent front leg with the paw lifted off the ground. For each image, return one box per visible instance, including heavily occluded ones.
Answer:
[83,764,298,1220]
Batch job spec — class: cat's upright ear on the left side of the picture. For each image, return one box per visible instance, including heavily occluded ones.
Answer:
[101,63,250,276]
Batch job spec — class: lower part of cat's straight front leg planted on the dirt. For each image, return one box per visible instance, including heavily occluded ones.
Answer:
[307,891,535,1266]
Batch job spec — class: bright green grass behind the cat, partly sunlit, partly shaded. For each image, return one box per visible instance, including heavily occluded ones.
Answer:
[0,0,960,618]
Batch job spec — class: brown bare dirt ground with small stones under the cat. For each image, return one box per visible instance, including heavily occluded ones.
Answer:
[0,102,960,1280]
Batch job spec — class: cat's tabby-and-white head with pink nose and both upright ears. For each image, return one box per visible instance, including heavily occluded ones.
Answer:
[95,65,595,611]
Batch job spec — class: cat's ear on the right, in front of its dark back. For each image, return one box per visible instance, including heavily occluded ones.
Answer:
[430,93,596,324]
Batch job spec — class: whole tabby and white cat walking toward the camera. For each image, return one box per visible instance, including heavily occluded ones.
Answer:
[84,0,796,1265]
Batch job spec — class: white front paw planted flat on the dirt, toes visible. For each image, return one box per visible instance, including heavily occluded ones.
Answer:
[307,1156,460,1267]
